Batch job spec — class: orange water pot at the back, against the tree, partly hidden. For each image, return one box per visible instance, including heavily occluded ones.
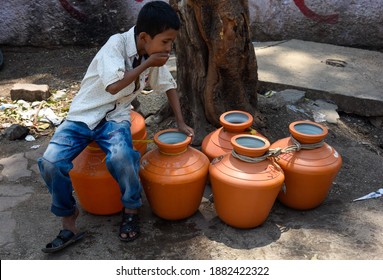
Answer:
[201,110,267,161]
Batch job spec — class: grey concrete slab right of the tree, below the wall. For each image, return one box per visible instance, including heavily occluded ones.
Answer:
[254,40,383,117]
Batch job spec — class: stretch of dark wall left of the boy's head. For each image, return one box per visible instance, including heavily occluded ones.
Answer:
[0,0,147,46]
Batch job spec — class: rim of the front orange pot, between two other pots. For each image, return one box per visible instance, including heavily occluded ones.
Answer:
[231,134,270,157]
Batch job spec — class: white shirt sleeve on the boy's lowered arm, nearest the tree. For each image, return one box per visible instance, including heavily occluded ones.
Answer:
[149,65,177,92]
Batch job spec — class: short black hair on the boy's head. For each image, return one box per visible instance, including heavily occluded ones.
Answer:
[134,1,180,38]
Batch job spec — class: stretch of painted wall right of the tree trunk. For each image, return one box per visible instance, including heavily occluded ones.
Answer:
[249,0,383,48]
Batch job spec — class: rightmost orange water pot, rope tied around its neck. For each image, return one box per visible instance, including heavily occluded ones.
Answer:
[270,121,342,210]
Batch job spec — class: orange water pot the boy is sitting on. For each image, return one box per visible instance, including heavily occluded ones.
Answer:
[69,111,147,215]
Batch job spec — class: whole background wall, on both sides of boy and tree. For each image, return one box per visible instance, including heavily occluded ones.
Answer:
[0,0,383,48]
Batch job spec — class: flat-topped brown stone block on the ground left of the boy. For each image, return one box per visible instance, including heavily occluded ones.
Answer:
[11,84,50,102]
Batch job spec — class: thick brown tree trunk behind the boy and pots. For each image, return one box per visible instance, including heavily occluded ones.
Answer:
[170,0,258,142]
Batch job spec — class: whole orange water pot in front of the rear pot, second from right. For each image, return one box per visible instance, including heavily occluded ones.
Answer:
[209,134,284,228]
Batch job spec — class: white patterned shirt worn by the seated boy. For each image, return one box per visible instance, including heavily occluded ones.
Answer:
[67,27,177,129]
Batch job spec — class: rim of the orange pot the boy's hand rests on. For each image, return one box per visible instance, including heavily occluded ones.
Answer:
[154,128,192,155]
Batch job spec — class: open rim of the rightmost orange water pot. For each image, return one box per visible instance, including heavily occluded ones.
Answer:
[289,121,328,144]
